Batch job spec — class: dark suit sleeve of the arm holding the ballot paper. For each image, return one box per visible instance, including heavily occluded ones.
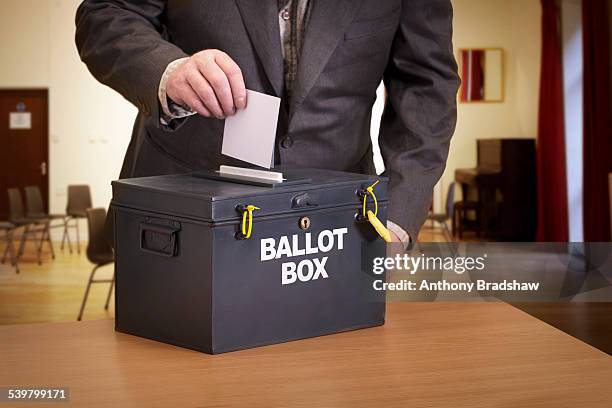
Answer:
[76,0,187,123]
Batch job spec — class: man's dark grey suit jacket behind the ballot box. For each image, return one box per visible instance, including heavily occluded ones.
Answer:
[76,0,458,237]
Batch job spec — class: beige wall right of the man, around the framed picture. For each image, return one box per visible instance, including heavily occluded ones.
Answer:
[435,0,541,209]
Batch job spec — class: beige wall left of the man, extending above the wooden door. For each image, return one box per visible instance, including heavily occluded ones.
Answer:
[0,0,136,220]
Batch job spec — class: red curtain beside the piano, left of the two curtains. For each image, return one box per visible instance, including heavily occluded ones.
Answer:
[537,0,569,242]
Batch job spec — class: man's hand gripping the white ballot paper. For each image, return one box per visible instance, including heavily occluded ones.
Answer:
[166,50,247,119]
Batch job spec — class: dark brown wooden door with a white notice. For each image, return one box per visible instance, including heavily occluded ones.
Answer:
[0,89,49,220]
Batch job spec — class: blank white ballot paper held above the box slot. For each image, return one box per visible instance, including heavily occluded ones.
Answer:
[221,89,280,169]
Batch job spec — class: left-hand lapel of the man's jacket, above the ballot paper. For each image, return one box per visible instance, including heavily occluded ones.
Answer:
[236,0,285,96]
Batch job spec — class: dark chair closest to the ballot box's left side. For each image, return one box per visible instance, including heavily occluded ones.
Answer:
[77,208,115,320]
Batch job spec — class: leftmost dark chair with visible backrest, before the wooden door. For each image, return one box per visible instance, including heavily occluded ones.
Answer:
[8,188,55,265]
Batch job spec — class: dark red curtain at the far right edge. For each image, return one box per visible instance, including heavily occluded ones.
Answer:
[582,0,612,242]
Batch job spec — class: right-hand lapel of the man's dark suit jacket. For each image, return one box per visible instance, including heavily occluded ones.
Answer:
[289,0,361,116]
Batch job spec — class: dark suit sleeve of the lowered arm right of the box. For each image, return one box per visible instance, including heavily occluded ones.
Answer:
[379,0,459,239]
